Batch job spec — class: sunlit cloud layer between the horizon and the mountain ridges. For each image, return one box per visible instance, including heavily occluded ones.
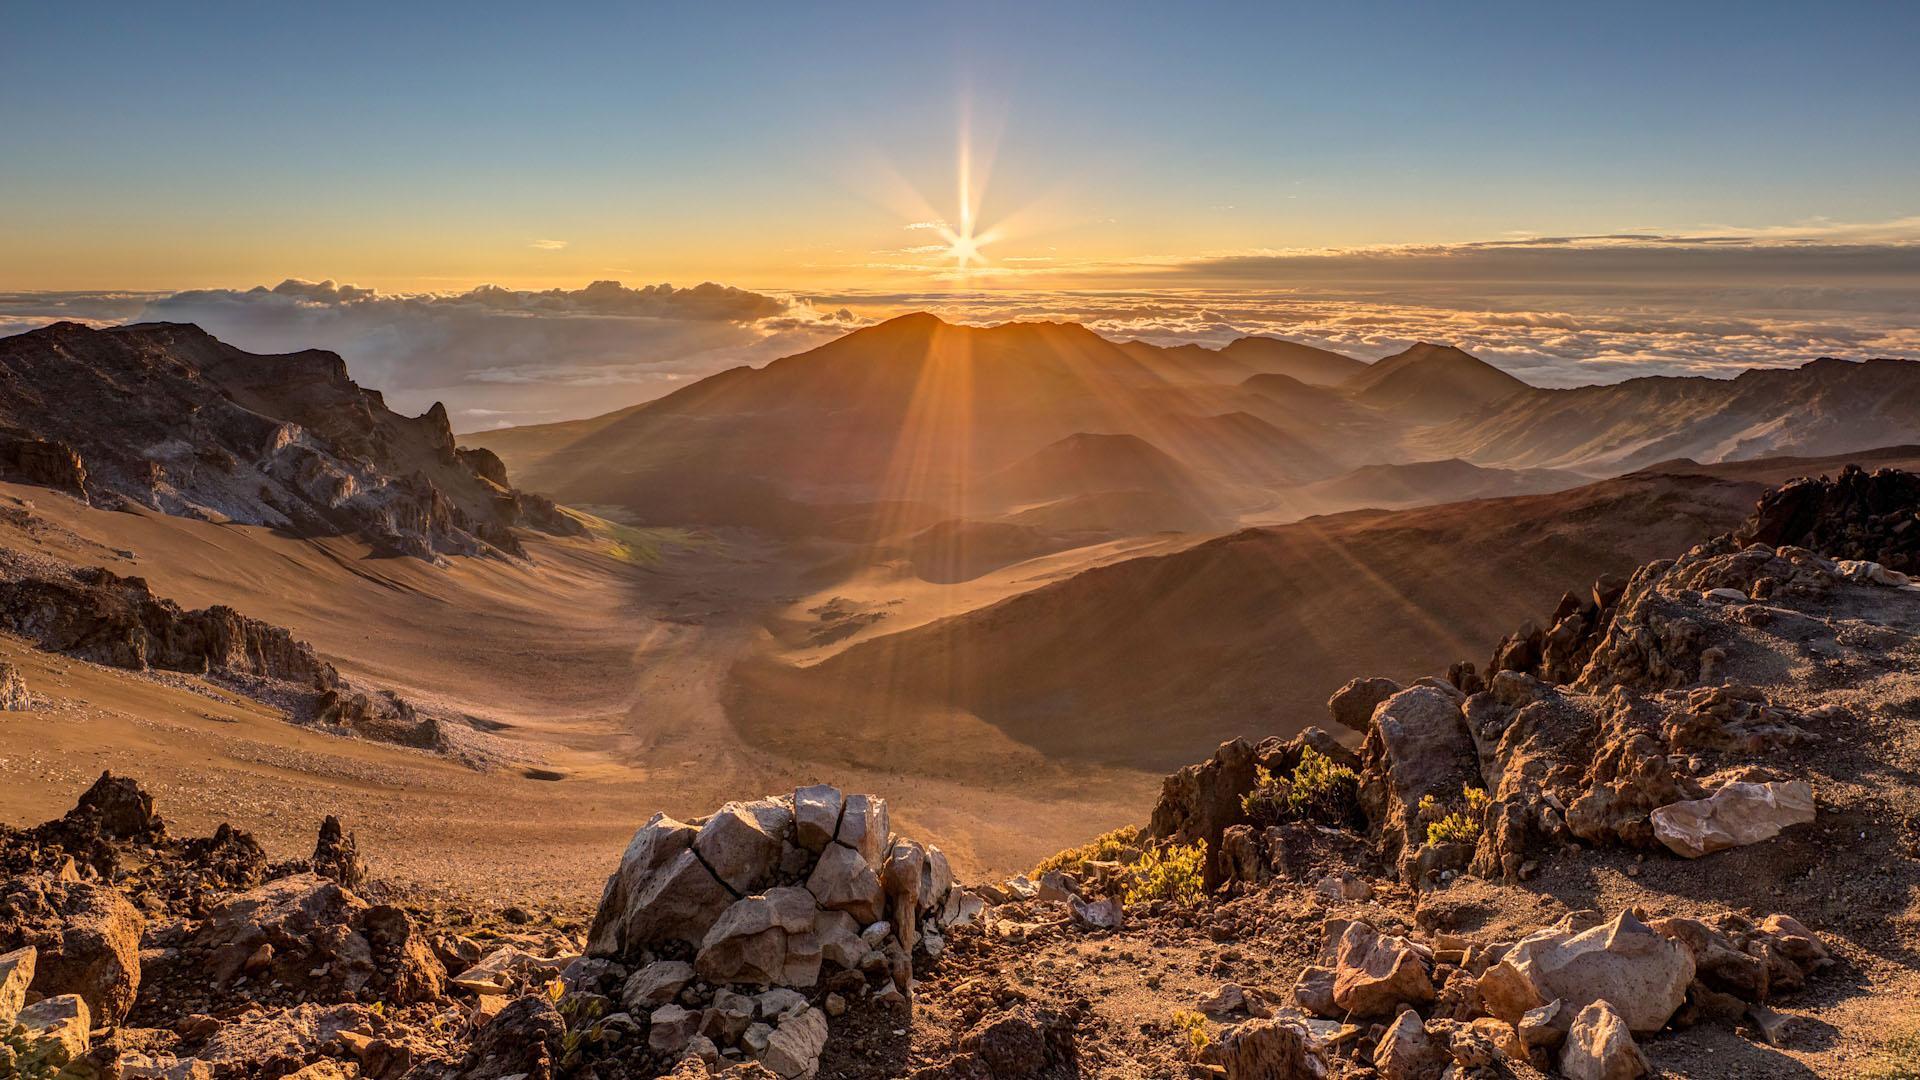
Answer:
[0,234,1920,430]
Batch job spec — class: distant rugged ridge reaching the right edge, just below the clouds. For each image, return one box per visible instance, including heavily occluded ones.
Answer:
[1419,359,1920,475]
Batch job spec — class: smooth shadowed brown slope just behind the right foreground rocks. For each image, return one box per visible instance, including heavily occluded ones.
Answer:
[732,445,1910,767]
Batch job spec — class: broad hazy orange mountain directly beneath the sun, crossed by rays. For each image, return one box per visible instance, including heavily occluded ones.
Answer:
[470,315,1340,530]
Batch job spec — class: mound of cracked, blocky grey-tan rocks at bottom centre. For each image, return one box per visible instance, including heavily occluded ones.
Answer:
[572,786,979,1078]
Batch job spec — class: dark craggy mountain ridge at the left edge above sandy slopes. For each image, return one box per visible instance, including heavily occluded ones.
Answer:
[0,323,578,557]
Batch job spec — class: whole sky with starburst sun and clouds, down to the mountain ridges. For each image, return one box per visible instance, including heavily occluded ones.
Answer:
[0,0,1920,425]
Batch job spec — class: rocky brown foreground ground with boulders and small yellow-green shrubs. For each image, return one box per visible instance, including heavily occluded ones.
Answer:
[0,469,1920,1080]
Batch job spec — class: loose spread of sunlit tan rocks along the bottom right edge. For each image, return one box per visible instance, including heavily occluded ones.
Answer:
[1200,899,1832,1080]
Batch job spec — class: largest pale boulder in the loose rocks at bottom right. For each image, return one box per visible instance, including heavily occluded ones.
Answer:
[1478,913,1693,1042]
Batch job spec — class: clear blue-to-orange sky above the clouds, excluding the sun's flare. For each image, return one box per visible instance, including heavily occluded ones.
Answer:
[0,2,1920,288]
